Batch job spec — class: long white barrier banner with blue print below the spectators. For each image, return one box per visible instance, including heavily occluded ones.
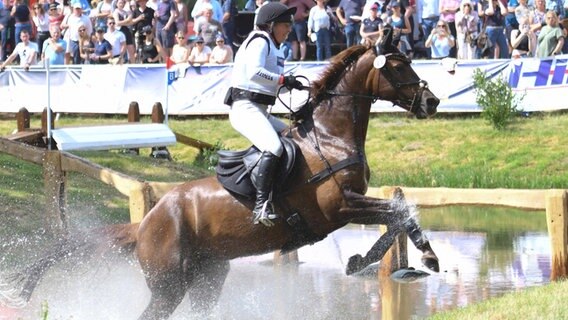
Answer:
[0,55,568,115]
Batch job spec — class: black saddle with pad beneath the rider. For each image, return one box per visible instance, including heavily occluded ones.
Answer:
[215,137,298,200]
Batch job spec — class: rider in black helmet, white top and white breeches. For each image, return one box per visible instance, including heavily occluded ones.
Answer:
[226,2,303,226]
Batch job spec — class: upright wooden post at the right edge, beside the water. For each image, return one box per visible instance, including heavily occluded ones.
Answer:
[546,190,568,281]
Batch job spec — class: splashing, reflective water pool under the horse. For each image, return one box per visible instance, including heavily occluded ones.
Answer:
[0,208,550,320]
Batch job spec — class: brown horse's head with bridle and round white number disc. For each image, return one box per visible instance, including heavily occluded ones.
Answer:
[366,25,440,119]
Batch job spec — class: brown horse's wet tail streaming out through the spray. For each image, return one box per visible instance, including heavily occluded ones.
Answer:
[0,223,140,308]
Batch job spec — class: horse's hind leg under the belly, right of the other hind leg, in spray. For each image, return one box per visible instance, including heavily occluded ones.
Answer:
[189,259,231,316]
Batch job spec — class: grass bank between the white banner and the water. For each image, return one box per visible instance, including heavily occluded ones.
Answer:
[0,114,568,189]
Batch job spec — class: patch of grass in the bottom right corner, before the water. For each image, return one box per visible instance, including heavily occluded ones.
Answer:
[428,281,568,320]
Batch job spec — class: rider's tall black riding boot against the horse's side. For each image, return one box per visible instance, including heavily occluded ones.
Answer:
[252,151,279,227]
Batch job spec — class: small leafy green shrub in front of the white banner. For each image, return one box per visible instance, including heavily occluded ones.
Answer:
[473,68,524,130]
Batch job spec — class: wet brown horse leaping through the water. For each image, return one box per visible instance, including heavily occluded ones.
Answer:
[3,30,439,319]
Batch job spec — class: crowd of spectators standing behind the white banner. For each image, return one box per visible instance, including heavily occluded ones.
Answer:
[0,0,568,69]
